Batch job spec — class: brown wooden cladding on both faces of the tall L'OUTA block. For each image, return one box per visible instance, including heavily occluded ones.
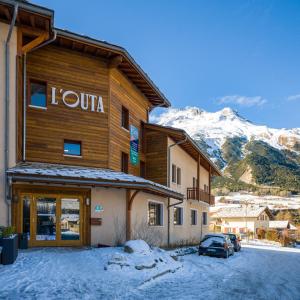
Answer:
[18,45,150,175]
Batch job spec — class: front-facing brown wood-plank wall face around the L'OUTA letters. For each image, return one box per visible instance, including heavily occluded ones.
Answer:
[18,45,108,168]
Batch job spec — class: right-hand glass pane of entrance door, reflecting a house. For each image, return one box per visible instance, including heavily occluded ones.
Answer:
[61,199,80,240]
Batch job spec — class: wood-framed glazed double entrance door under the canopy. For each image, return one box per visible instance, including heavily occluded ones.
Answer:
[21,194,83,246]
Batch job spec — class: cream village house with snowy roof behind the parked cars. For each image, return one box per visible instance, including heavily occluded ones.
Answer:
[211,205,273,236]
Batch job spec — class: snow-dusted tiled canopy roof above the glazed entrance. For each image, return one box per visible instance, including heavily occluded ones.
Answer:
[7,162,183,200]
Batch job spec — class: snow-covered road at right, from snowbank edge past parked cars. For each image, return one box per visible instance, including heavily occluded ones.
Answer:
[136,248,300,300]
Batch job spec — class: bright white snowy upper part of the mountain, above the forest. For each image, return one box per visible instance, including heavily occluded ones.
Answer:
[151,107,300,159]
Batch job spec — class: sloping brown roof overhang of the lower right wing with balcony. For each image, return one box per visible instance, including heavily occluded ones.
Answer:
[145,123,222,176]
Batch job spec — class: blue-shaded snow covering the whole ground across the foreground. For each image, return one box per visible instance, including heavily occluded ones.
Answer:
[0,246,300,300]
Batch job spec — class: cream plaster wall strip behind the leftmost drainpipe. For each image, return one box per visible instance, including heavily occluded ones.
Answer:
[0,22,17,225]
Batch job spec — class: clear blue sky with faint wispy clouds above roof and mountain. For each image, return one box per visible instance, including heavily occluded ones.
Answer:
[33,0,300,128]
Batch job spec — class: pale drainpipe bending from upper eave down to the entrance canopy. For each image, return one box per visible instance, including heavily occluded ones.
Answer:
[22,30,57,162]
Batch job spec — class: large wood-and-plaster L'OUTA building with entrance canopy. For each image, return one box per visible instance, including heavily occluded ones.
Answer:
[0,0,221,247]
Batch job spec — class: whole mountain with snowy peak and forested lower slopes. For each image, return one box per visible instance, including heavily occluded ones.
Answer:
[150,107,300,191]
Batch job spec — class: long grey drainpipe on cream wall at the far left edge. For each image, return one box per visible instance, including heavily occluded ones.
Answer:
[4,3,19,226]
